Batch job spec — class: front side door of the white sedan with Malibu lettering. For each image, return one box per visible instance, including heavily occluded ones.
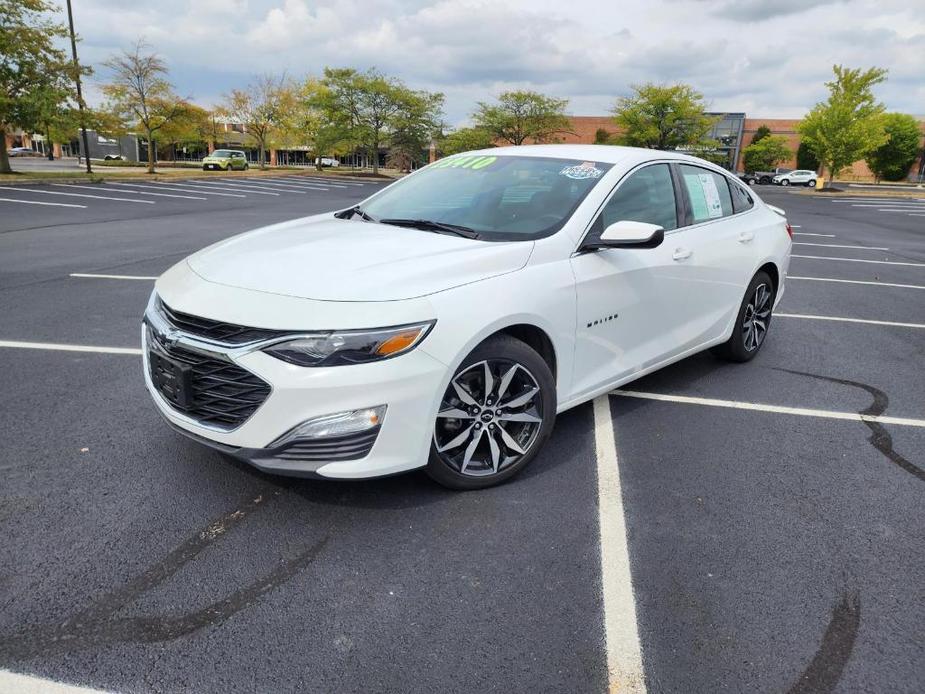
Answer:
[571,163,696,397]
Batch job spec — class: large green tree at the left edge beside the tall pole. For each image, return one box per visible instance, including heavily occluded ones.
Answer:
[0,0,77,173]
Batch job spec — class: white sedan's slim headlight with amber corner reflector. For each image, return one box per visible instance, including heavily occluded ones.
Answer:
[263,321,435,366]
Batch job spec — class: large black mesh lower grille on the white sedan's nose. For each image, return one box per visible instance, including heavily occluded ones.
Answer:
[148,328,270,430]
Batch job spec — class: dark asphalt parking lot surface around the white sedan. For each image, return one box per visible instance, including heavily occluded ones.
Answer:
[0,181,925,693]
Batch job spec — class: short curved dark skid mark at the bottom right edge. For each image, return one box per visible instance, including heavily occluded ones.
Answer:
[787,590,861,694]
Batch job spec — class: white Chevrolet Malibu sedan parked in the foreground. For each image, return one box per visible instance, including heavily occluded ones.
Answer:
[142,145,791,489]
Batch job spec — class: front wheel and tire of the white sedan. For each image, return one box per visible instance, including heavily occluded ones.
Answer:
[426,335,556,489]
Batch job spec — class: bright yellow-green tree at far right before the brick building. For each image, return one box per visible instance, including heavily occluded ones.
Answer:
[797,65,888,184]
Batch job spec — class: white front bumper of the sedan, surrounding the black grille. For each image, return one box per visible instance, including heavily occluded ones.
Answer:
[142,308,447,479]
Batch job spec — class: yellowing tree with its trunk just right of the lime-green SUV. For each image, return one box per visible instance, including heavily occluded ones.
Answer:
[218,74,298,168]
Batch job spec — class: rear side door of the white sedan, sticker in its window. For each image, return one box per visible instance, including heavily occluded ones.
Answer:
[676,164,756,349]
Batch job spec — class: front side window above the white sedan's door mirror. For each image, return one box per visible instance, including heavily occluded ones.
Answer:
[595,164,678,234]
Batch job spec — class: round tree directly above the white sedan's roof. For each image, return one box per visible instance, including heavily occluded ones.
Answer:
[472,91,572,145]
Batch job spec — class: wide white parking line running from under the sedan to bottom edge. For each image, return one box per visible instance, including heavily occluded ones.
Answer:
[594,395,646,692]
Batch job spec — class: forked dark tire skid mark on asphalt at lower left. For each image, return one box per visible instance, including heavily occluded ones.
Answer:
[0,486,328,661]
